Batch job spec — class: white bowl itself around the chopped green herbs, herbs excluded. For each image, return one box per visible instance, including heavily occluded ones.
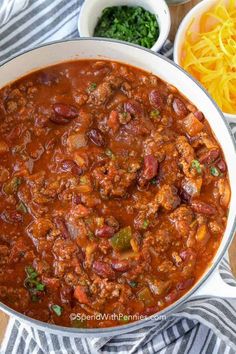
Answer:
[78,0,171,52]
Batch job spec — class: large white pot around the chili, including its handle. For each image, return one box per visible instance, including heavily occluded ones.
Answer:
[0,38,236,337]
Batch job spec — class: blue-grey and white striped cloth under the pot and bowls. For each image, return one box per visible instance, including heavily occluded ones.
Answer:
[0,0,236,354]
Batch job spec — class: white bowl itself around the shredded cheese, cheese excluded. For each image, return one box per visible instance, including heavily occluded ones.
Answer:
[174,0,236,123]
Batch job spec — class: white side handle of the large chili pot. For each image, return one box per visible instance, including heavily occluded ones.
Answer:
[194,267,236,298]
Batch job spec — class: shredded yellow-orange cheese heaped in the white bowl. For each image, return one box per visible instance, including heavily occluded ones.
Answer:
[181,0,236,114]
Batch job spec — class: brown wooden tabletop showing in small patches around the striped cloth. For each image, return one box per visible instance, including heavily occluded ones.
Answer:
[0,0,236,343]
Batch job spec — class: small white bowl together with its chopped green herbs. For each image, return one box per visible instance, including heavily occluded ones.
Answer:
[78,0,171,52]
